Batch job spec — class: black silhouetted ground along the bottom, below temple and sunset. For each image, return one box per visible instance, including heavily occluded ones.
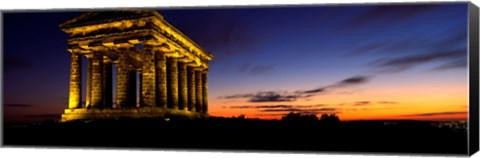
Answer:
[3,118,467,155]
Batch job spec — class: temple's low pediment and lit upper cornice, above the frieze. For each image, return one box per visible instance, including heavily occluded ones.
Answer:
[59,10,213,60]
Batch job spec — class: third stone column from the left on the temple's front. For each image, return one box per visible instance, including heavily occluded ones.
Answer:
[116,54,130,108]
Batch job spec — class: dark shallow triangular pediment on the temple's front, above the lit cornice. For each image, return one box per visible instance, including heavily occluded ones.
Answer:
[60,10,162,29]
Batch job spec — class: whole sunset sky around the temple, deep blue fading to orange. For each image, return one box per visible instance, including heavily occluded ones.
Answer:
[2,3,468,121]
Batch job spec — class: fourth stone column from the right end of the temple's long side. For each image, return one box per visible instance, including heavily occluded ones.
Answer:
[178,62,188,111]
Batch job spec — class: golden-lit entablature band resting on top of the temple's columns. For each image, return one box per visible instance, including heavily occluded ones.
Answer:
[60,11,213,68]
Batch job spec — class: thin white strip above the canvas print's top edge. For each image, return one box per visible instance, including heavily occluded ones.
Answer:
[0,0,472,10]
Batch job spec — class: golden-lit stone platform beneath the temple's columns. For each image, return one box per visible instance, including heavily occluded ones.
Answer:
[60,107,208,122]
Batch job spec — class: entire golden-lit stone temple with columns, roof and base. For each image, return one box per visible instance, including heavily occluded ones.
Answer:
[60,10,213,122]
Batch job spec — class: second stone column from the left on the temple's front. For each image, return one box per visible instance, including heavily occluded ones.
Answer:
[92,52,104,108]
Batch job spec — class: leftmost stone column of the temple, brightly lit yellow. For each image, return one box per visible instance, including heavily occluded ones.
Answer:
[68,53,82,109]
